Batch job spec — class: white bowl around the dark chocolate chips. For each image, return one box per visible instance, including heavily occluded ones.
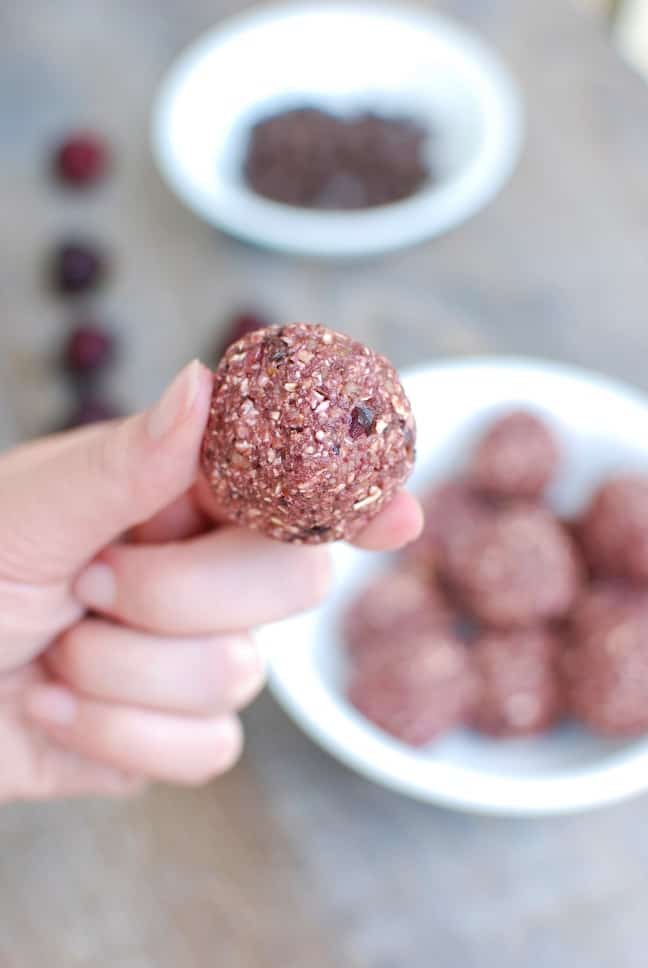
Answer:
[152,3,522,256]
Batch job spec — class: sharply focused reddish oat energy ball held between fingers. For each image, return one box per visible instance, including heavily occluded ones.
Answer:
[202,323,415,544]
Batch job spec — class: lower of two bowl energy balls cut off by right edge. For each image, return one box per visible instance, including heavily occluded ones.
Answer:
[562,582,648,736]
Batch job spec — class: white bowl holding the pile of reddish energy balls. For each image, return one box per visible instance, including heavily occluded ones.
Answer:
[259,359,648,815]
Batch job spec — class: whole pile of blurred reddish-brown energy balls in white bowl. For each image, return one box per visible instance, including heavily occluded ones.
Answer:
[343,411,648,746]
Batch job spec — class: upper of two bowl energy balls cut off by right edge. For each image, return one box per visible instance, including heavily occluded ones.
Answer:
[580,476,648,581]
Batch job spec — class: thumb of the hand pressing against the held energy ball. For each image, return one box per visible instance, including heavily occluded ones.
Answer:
[0,361,212,582]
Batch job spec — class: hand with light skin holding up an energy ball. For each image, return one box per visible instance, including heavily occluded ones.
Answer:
[0,362,422,801]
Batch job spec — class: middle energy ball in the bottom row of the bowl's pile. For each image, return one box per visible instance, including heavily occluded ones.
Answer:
[472,628,564,737]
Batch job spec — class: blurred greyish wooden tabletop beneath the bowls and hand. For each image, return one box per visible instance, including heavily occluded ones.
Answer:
[0,0,648,968]
